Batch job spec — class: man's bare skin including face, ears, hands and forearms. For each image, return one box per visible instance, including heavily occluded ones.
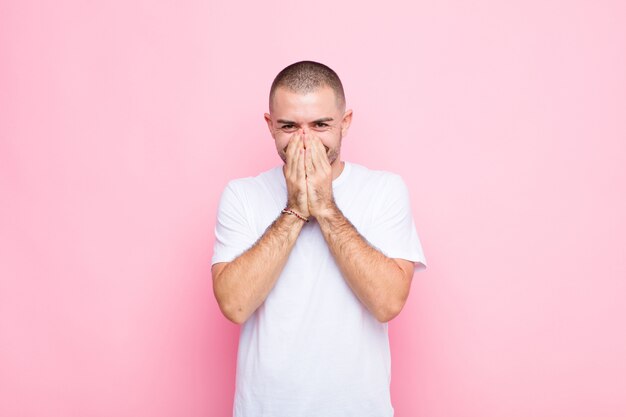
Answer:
[212,87,414,324]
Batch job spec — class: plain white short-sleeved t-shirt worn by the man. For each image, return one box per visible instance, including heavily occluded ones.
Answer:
[212,162,426,417]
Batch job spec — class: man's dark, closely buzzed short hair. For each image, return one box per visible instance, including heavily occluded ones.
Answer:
[269,61,346,108]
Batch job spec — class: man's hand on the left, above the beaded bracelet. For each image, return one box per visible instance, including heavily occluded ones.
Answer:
[283,131,310,217]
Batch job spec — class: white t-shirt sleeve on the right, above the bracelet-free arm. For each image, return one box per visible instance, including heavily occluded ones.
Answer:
[366,174,427,271]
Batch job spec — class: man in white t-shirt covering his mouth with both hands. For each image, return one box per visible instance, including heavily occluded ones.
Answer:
[212,61,426,417]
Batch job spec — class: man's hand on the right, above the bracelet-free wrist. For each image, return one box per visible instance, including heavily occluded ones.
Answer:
[304,135,335,218]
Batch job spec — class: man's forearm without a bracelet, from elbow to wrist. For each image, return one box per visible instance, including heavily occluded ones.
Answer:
[317,204,408,322]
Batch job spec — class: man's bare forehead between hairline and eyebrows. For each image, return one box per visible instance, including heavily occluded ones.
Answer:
[270,86,340,121]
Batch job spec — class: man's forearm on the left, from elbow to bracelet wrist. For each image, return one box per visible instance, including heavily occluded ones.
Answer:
[213,214,304,323]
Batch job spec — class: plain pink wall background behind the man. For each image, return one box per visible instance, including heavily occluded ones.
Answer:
[0,0,626,417]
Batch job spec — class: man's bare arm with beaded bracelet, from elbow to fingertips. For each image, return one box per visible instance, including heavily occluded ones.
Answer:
[211,134,309,324]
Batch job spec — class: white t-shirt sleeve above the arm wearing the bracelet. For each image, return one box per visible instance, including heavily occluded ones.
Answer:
[211,181,256,265]
